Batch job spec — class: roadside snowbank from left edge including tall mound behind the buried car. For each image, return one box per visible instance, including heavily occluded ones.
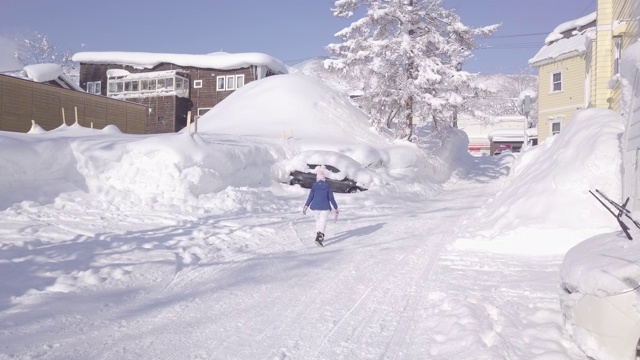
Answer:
[0,74,466,211]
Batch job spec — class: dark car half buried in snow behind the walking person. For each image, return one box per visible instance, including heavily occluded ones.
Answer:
[288,150,376,193]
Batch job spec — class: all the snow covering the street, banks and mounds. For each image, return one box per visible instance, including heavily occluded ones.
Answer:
[0,70,638,359]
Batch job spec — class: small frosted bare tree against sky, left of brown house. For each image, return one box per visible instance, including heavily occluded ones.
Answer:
[14,31,77,74]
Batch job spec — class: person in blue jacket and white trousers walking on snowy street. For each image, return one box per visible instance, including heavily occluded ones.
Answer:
[302,168,340,246]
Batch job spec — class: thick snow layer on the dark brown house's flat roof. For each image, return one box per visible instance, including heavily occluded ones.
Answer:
[72,51,288,74]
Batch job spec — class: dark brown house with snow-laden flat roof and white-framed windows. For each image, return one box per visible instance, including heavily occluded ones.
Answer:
[73,52,287,134]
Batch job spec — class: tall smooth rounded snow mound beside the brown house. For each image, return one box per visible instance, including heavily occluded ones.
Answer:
[198,73,388,150]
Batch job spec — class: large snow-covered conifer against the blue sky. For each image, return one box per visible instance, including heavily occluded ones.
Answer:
[325,0,498,140]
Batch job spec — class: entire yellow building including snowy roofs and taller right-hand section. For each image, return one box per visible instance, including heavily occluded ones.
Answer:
[529,0,640,142]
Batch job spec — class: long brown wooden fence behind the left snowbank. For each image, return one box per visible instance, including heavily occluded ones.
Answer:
[0,75,148,134]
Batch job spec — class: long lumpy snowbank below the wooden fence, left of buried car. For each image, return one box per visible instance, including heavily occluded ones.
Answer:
[0,125,285,212]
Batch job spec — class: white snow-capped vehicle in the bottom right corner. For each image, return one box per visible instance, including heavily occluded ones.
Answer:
[560,234,640,360]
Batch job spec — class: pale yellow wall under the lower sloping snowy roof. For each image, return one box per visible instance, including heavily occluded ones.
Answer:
[538,56,586,143]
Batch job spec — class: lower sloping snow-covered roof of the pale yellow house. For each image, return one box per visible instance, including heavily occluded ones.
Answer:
[529,27,596,66]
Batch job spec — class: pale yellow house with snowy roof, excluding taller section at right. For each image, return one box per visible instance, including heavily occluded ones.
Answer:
[529,12,596,143]
